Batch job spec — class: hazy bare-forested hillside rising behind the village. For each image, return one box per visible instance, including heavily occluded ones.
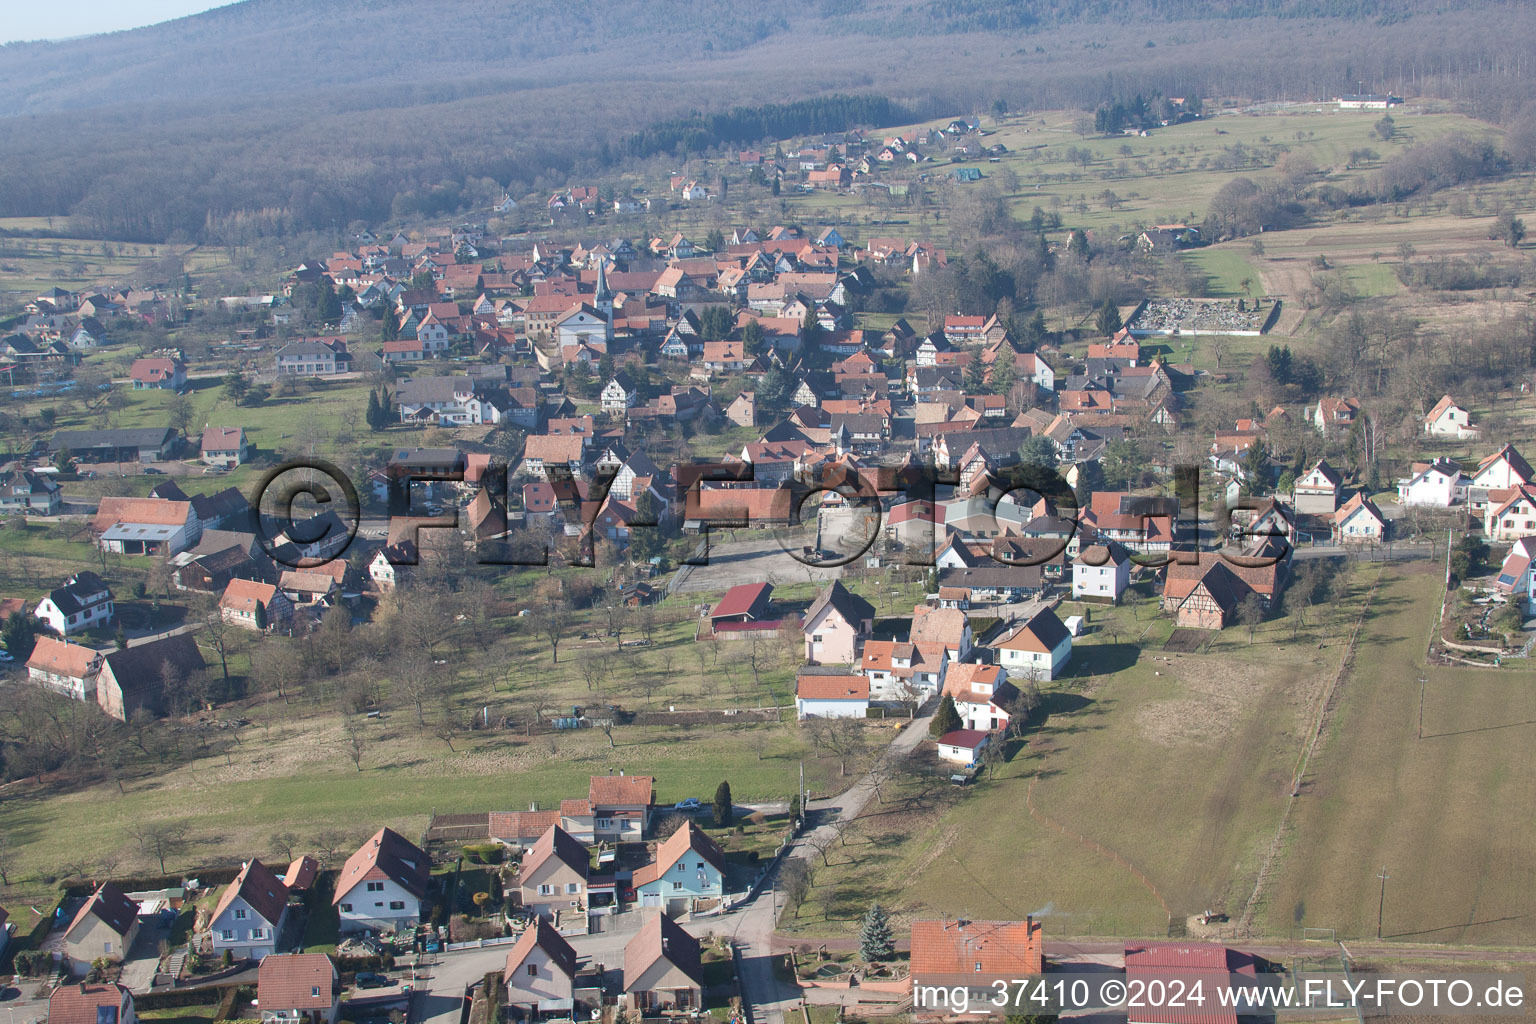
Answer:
[0,0,1536,241]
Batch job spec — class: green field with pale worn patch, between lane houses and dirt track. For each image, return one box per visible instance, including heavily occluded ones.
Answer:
[791,574,1339,936]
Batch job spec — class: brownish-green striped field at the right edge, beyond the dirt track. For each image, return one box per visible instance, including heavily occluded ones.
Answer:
[1261,571,1536,946]
